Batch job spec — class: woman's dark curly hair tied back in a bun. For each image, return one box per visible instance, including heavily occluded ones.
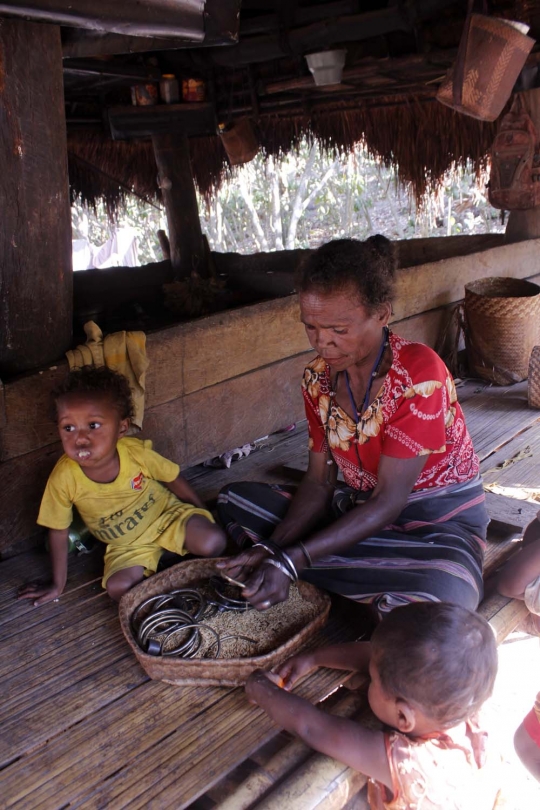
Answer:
[296,234,397,309]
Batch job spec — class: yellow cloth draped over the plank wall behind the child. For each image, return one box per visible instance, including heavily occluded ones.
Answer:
[66,321,148,429]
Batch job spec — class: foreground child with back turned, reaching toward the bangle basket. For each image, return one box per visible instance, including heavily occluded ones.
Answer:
[246,602,497,810]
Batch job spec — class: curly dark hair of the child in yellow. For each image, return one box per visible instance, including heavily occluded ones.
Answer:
[53,366,133,419]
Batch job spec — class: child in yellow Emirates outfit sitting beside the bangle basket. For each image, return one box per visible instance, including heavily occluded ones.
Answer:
[19,366,225,605]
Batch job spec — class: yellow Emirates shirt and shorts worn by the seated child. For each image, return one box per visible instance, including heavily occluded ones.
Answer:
[37,437,214,587]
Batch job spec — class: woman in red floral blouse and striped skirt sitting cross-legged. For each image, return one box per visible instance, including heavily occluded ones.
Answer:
[218,236,488,614]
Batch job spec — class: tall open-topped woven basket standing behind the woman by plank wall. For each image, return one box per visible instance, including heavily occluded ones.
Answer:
[464,278,540,385]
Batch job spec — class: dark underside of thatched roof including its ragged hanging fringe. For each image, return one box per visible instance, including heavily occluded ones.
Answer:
[64,0,540,214]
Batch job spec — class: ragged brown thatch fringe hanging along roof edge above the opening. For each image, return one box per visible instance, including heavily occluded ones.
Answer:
[68,98,496,217]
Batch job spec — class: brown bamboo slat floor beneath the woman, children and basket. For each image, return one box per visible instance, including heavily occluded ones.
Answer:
[0,381,540,810]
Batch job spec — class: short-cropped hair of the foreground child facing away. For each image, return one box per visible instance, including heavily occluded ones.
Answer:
[371,602,497,728]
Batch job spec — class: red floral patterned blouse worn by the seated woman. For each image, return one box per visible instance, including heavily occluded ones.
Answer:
[302,333,479,490]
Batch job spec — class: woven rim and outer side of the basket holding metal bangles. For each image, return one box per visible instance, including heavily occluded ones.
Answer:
[119,559,330,686]
